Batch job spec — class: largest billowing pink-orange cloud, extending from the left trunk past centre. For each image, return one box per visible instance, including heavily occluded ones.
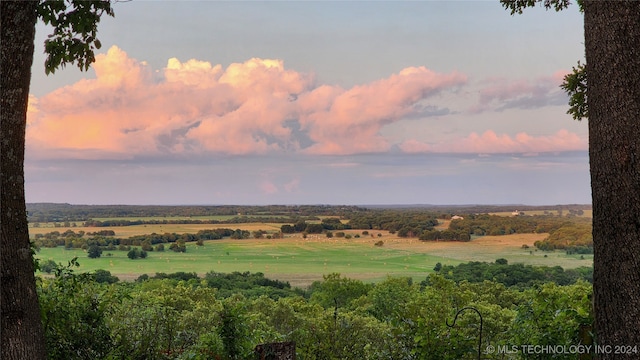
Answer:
[27,47,466,159]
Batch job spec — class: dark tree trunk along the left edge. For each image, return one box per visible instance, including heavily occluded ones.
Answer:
[0,1,46,360]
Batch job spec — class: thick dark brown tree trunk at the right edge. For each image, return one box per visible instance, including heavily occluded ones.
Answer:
[584,1,640,359]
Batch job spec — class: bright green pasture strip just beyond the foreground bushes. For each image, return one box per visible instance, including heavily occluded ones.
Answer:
[36,240,450,285]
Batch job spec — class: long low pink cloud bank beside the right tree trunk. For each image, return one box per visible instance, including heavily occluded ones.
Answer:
[399,129,588,154]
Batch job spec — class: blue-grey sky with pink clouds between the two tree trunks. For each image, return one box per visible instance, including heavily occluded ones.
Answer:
[25,0,591,205]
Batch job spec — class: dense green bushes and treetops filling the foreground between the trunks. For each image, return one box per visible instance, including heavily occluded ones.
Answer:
[38,261,592,360]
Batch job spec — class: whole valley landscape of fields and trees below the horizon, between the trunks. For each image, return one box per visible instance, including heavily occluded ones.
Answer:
[28,204,593,359]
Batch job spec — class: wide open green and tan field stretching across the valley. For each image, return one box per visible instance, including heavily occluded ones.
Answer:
[36,232,592,287]
